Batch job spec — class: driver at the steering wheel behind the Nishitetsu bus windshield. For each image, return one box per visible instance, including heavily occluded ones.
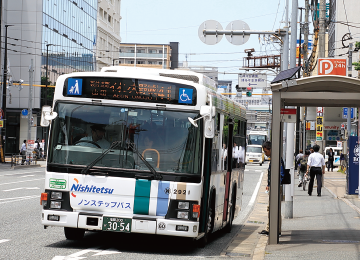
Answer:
[76,124,110,149]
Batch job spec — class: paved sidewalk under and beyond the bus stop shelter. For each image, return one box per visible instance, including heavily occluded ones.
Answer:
[222,169,360,259]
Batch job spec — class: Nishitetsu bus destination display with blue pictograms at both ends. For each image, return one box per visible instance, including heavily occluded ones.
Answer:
[63,77,196,105]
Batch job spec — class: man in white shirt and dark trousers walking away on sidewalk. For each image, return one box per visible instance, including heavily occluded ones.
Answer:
[306,144,325,197]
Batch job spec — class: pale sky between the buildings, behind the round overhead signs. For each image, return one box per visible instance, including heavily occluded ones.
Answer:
[120,0,292,88]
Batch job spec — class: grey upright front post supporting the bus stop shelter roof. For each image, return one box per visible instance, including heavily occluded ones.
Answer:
[269,92,282,245]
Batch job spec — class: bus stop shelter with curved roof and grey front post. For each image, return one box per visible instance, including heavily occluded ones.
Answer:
[269,75,360,244]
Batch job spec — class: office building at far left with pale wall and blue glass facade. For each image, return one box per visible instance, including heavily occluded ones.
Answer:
[1,0,97,154]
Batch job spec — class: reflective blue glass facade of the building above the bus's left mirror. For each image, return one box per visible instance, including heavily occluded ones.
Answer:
[41,0,97,83]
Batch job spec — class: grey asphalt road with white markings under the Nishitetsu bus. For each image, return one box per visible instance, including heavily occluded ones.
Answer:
[0,164,267,260]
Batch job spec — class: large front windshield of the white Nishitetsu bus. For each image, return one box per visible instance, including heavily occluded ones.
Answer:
[48,102,202,174]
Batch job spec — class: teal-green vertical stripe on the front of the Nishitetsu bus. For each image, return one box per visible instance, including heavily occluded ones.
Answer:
[134,180,151,215]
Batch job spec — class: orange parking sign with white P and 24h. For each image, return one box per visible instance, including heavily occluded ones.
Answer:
[318,58,347,76]
